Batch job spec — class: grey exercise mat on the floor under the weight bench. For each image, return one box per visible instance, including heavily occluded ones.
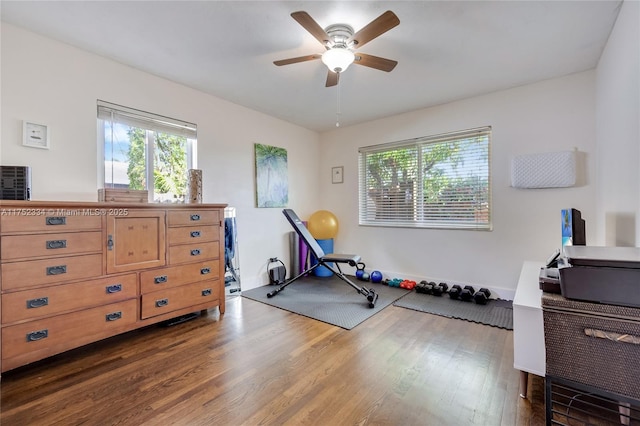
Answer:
[242,276,408,330]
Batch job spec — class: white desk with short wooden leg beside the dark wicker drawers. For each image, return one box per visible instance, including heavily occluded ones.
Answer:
[513,261,546,398]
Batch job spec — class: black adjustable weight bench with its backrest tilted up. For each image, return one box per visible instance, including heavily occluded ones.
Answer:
[267,209,378,308]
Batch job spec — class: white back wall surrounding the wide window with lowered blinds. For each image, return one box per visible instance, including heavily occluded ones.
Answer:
[321,71,596,297]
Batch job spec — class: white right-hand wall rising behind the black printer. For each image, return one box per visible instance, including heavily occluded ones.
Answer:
[596,1,640,247]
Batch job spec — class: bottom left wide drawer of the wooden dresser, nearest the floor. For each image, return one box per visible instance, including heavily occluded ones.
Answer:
[2,299,137,371]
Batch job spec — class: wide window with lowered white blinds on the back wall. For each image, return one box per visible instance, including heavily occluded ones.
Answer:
[358,127,491,230]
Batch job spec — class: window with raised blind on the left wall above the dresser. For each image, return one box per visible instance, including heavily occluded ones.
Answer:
[98,101,197,202]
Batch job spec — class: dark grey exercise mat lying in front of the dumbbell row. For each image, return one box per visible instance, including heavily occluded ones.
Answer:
[393,292,513,330]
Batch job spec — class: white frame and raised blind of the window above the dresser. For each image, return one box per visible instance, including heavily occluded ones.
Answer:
[96,100,198,202]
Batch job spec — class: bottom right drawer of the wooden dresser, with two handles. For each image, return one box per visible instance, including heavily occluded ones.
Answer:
[141,280,220,319]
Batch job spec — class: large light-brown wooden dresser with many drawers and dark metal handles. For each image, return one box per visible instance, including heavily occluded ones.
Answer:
[0,201,226,372]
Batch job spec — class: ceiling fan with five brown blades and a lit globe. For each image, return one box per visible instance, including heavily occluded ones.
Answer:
[273,10,400,87]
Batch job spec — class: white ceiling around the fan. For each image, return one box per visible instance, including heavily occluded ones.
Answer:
[0,0,621,131]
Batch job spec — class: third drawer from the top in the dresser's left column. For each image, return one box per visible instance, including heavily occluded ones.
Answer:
[2,254,102,291]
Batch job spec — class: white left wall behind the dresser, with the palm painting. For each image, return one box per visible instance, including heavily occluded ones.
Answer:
[0,23,319,289]
